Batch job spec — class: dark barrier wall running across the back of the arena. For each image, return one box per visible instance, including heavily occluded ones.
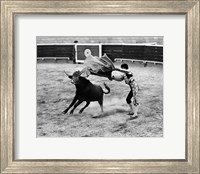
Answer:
[37,44,163,62]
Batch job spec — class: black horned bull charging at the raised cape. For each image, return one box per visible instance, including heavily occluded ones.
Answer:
[63,71,110,114]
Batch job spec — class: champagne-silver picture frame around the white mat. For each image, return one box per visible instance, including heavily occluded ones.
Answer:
[0,0,200,174]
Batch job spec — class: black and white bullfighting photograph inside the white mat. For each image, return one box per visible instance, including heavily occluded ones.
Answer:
[36,36,164,138]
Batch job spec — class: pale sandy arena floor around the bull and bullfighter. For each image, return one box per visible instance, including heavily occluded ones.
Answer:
[37,63,163,137]
